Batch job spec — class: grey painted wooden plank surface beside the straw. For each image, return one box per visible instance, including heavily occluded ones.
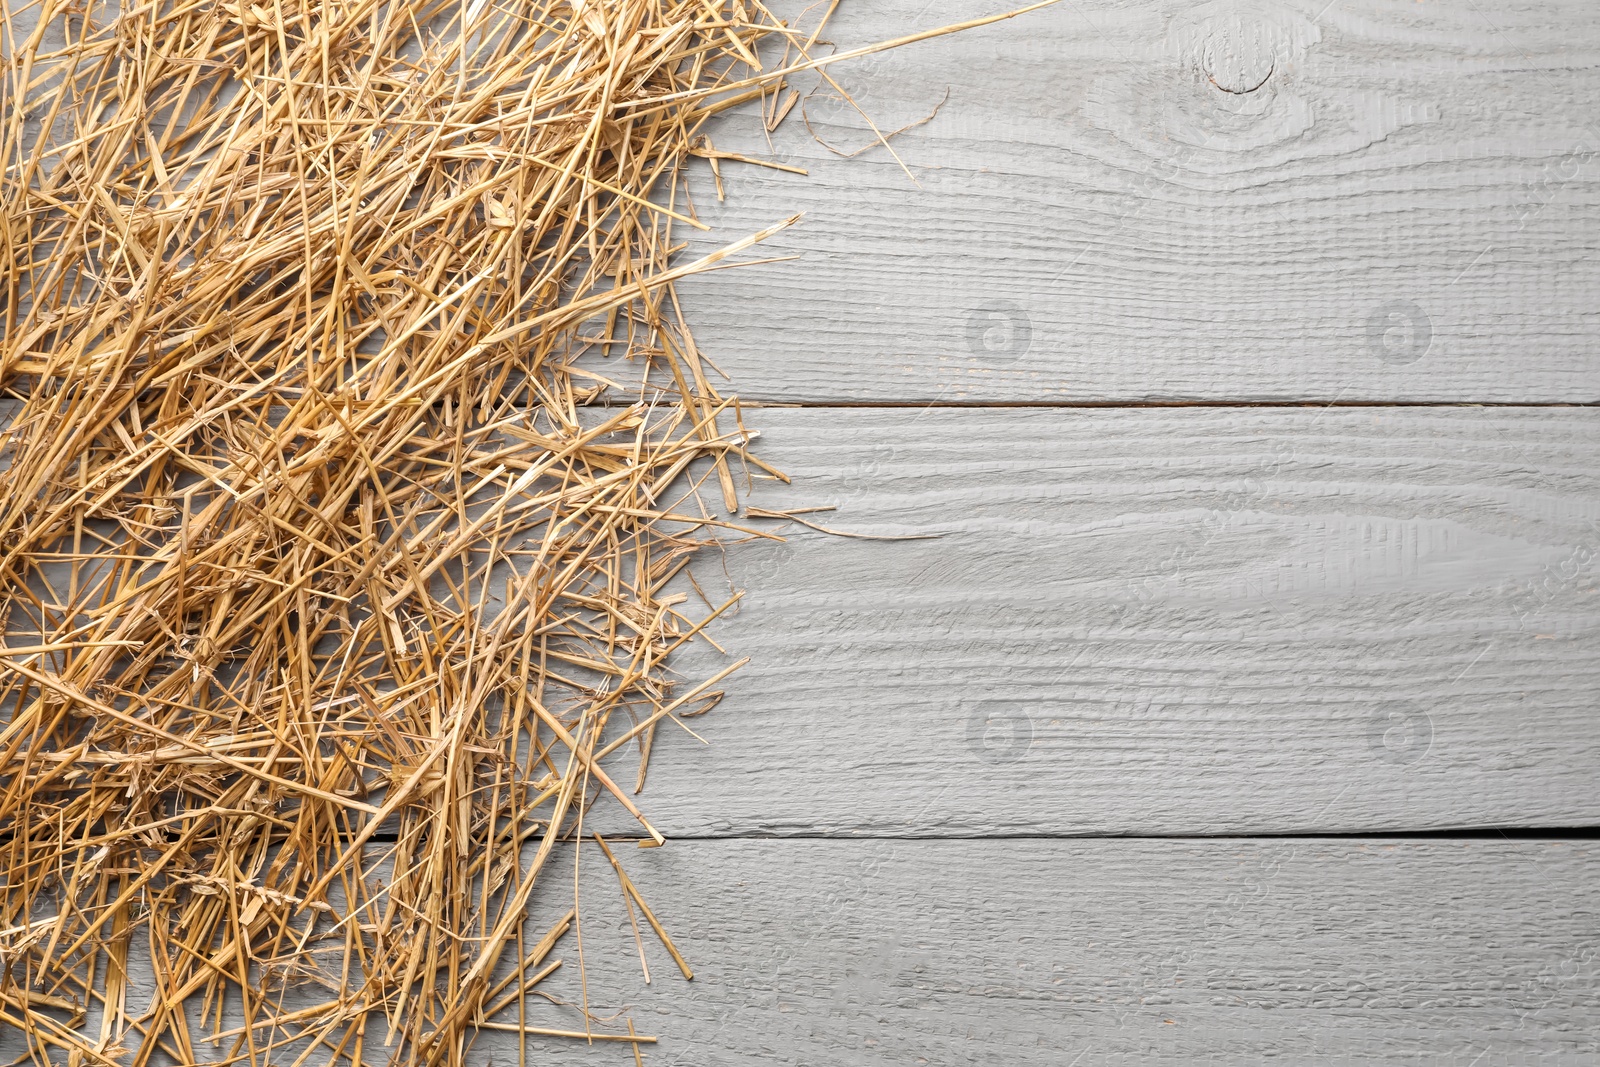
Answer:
[478,0,1600,1067]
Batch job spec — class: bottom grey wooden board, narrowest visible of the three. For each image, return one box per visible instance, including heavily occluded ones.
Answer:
[451,840,1600,1067]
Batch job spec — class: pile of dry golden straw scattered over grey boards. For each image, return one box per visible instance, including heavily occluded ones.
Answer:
[0,0,1043,1064]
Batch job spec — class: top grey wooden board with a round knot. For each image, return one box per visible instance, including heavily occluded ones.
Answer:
[668,0,1600,402]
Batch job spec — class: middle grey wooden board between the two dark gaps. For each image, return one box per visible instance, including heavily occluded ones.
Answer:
[608,408,1600,837]
